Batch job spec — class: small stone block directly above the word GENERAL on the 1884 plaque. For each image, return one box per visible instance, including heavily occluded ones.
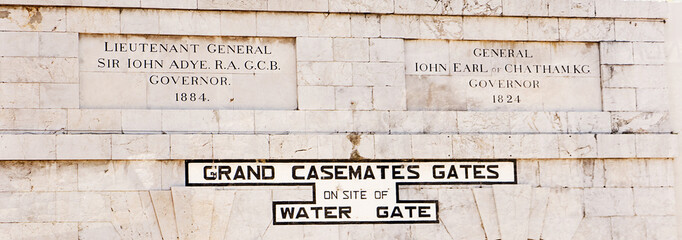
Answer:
[220,11,257,36]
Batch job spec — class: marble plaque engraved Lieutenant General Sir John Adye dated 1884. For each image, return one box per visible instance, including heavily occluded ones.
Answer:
[79,34,297,109]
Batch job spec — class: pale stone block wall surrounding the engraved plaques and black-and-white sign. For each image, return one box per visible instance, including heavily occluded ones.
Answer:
[0,0,677,239]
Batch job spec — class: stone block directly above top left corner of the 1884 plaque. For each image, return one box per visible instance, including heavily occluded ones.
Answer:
[66,8,119,33]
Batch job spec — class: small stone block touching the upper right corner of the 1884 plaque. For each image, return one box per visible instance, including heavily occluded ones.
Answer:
[296,37,334,62]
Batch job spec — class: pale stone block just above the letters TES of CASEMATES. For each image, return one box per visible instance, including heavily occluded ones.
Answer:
[374,135,412,159]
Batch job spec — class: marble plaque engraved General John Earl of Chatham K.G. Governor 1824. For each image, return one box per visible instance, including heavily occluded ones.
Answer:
[405,40,602,111]
